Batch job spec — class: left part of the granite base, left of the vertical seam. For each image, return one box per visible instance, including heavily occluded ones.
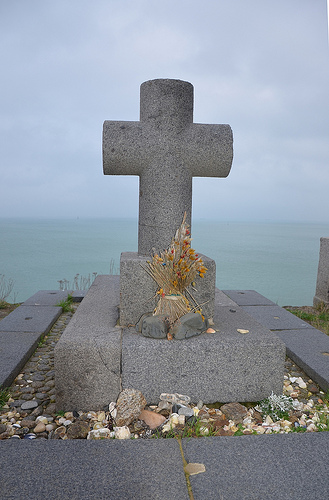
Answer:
[54,276,121,411]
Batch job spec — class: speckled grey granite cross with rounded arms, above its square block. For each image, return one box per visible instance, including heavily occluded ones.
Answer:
[103,79,233,255]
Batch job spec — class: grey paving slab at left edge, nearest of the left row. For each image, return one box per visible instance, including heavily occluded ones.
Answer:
[0,332,42,387]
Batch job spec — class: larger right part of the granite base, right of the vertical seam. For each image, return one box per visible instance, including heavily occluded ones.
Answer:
[122,303,285,403]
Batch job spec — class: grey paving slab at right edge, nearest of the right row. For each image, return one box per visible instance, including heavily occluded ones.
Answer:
[275,327,329,391]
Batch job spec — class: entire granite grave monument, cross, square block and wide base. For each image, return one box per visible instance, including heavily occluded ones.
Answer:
[55,79,285,410]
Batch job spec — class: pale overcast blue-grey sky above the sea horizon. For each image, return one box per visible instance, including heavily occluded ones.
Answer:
[0,0,329,223]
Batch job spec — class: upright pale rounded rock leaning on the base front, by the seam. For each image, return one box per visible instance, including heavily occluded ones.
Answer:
[115,389,146,427]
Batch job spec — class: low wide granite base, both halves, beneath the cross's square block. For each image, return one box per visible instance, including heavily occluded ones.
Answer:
[55,276,285,411]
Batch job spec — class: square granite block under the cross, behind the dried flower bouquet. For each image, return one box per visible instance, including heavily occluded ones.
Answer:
[120,252,216,326]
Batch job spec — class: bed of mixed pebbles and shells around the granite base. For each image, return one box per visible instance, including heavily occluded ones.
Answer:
[0,305,329,440]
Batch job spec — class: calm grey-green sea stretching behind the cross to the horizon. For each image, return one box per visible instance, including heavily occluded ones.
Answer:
[0,219,329,306]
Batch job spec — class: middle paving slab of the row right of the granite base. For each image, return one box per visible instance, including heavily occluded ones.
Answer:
[241,306,310,330]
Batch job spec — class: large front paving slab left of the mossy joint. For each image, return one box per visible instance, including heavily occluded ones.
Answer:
[0,439,189,500]
